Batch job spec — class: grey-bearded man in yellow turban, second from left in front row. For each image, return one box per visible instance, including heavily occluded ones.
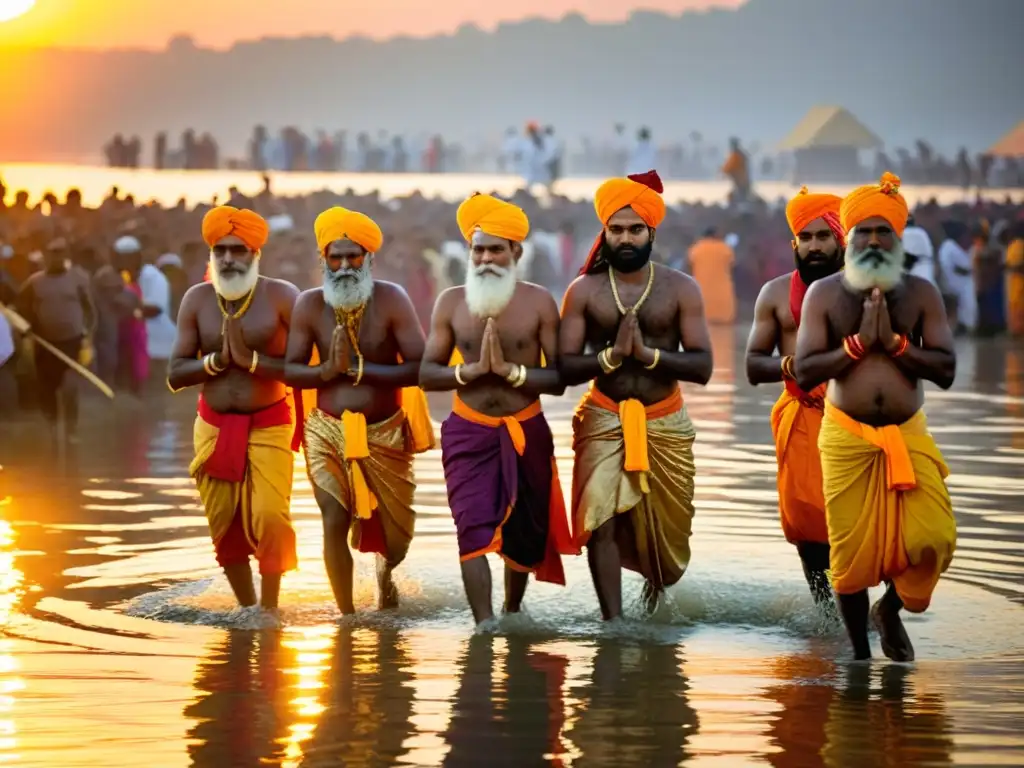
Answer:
[287,207,433,614]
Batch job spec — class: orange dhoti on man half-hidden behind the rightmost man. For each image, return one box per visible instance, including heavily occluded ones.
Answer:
[771,382,828,544]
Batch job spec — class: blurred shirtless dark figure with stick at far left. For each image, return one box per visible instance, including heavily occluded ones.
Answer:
[14,238,96,442]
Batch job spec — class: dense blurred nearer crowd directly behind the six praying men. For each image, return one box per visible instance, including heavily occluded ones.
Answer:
[0,172,1024,423]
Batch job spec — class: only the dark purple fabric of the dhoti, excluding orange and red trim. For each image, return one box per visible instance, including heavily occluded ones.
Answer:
[441,414,554,568]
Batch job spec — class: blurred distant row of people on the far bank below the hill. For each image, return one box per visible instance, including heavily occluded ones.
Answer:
[103,121,1024,188]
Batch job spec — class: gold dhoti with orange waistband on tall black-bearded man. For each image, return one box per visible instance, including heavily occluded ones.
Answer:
[572,387,695,589]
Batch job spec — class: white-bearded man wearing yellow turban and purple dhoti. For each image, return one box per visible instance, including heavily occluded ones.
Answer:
[420,195,574,630]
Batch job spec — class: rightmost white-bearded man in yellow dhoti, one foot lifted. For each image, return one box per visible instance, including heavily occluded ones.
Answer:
[795,173,956,662]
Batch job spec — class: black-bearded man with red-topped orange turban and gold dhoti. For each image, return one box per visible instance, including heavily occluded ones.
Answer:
[559,171,712,620]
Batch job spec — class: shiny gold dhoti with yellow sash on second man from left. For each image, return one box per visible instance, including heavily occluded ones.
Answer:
[303,409,417,566]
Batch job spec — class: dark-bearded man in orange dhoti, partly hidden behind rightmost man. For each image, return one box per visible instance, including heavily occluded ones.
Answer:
[746,186,845,603]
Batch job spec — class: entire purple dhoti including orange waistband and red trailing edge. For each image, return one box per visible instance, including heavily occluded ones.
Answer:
[441,397,578,585]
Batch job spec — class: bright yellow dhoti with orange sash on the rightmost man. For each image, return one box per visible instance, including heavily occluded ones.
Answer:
[818,402,956,612]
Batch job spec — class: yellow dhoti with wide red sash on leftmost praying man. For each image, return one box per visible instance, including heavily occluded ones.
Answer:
[188,396,297,573]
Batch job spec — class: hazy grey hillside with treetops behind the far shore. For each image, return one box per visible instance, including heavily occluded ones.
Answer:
[0,0,1024,161]
